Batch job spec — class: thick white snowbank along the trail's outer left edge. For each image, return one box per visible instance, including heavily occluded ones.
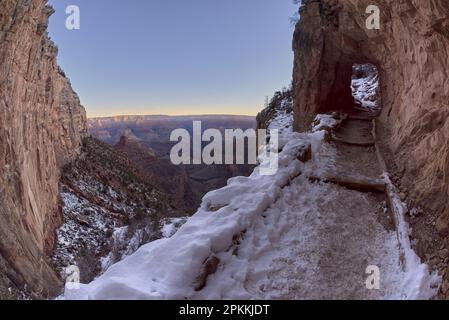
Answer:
[64,131,318,300]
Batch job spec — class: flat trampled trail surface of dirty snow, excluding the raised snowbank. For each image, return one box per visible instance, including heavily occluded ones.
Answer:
[195,120,403,299]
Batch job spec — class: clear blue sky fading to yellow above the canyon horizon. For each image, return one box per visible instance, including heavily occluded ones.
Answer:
[49,0,297,117]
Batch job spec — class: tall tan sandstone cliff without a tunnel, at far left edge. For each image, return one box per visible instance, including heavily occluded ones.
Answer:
[0,0,87,296]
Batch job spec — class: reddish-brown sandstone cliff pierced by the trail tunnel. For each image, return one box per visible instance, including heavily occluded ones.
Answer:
[293,0,449,235]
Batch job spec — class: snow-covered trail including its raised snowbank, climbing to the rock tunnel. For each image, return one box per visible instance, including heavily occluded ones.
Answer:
[65,115,438,299]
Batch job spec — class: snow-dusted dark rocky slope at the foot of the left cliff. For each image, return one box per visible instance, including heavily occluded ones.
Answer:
[53,138,175,282]
